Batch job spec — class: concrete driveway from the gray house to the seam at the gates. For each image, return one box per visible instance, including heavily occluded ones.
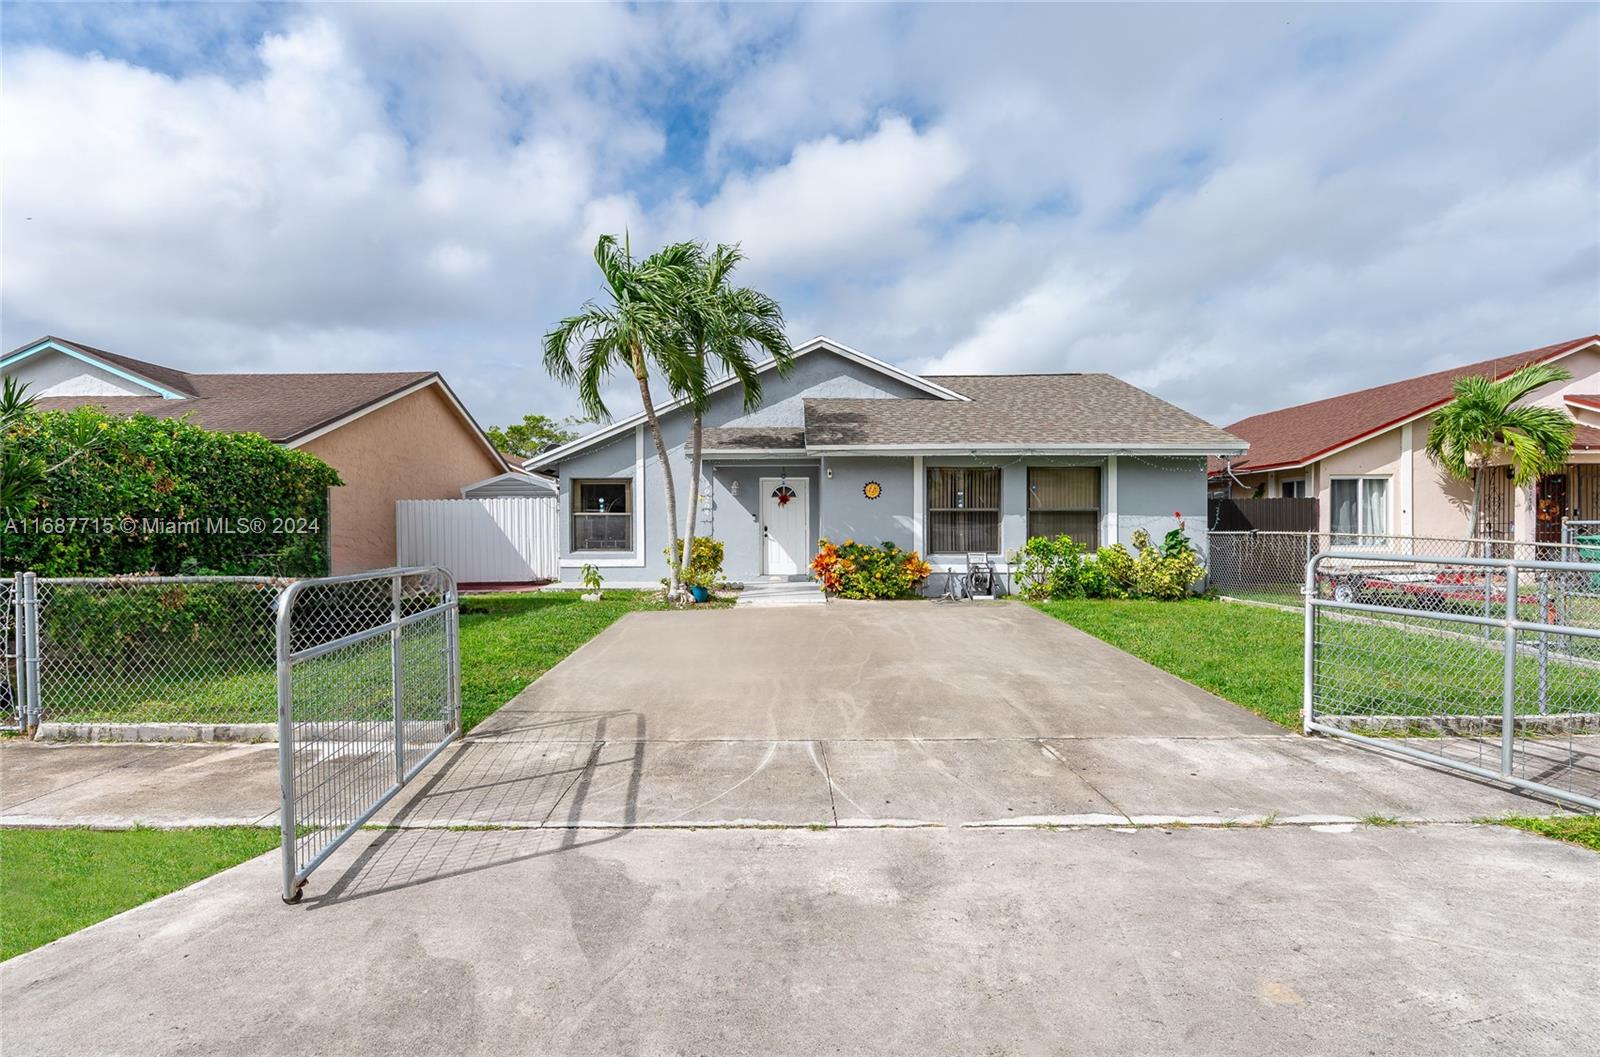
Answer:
[371,603,1547,827]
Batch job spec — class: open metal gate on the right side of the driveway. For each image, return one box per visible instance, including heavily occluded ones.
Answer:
[1304,550,1600,809]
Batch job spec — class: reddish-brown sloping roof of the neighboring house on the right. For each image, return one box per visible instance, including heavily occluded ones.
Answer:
[1227,334,1600,472]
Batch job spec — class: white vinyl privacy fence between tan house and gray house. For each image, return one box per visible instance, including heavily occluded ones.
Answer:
[395,496,562,584]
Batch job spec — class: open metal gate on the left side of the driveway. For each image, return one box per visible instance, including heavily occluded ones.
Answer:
[277,566,461,903]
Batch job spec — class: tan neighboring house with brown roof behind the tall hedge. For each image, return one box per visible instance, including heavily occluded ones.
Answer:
[0,336,509,572]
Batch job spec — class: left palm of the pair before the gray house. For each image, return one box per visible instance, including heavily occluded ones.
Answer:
[544,235,706,596]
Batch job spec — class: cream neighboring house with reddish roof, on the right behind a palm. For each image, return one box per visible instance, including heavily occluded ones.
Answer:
[1211,334,1600,542]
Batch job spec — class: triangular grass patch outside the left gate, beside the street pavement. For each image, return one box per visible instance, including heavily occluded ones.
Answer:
[0,827,278,959]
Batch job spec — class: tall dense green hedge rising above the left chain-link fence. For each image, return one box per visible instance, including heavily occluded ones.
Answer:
[0,408,341,576]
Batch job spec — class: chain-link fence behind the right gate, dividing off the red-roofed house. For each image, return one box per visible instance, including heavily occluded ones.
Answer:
[1206,532,1580,609]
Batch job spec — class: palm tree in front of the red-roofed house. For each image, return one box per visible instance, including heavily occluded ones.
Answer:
[1427,363,1576,537]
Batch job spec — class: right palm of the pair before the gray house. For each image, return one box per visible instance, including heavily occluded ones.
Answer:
[678,245,795,585]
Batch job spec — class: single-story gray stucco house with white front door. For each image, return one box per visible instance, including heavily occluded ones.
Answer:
[525,337,1246,592]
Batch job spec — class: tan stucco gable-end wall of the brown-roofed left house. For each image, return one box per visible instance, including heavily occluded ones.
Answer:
[301,385,504,574]
